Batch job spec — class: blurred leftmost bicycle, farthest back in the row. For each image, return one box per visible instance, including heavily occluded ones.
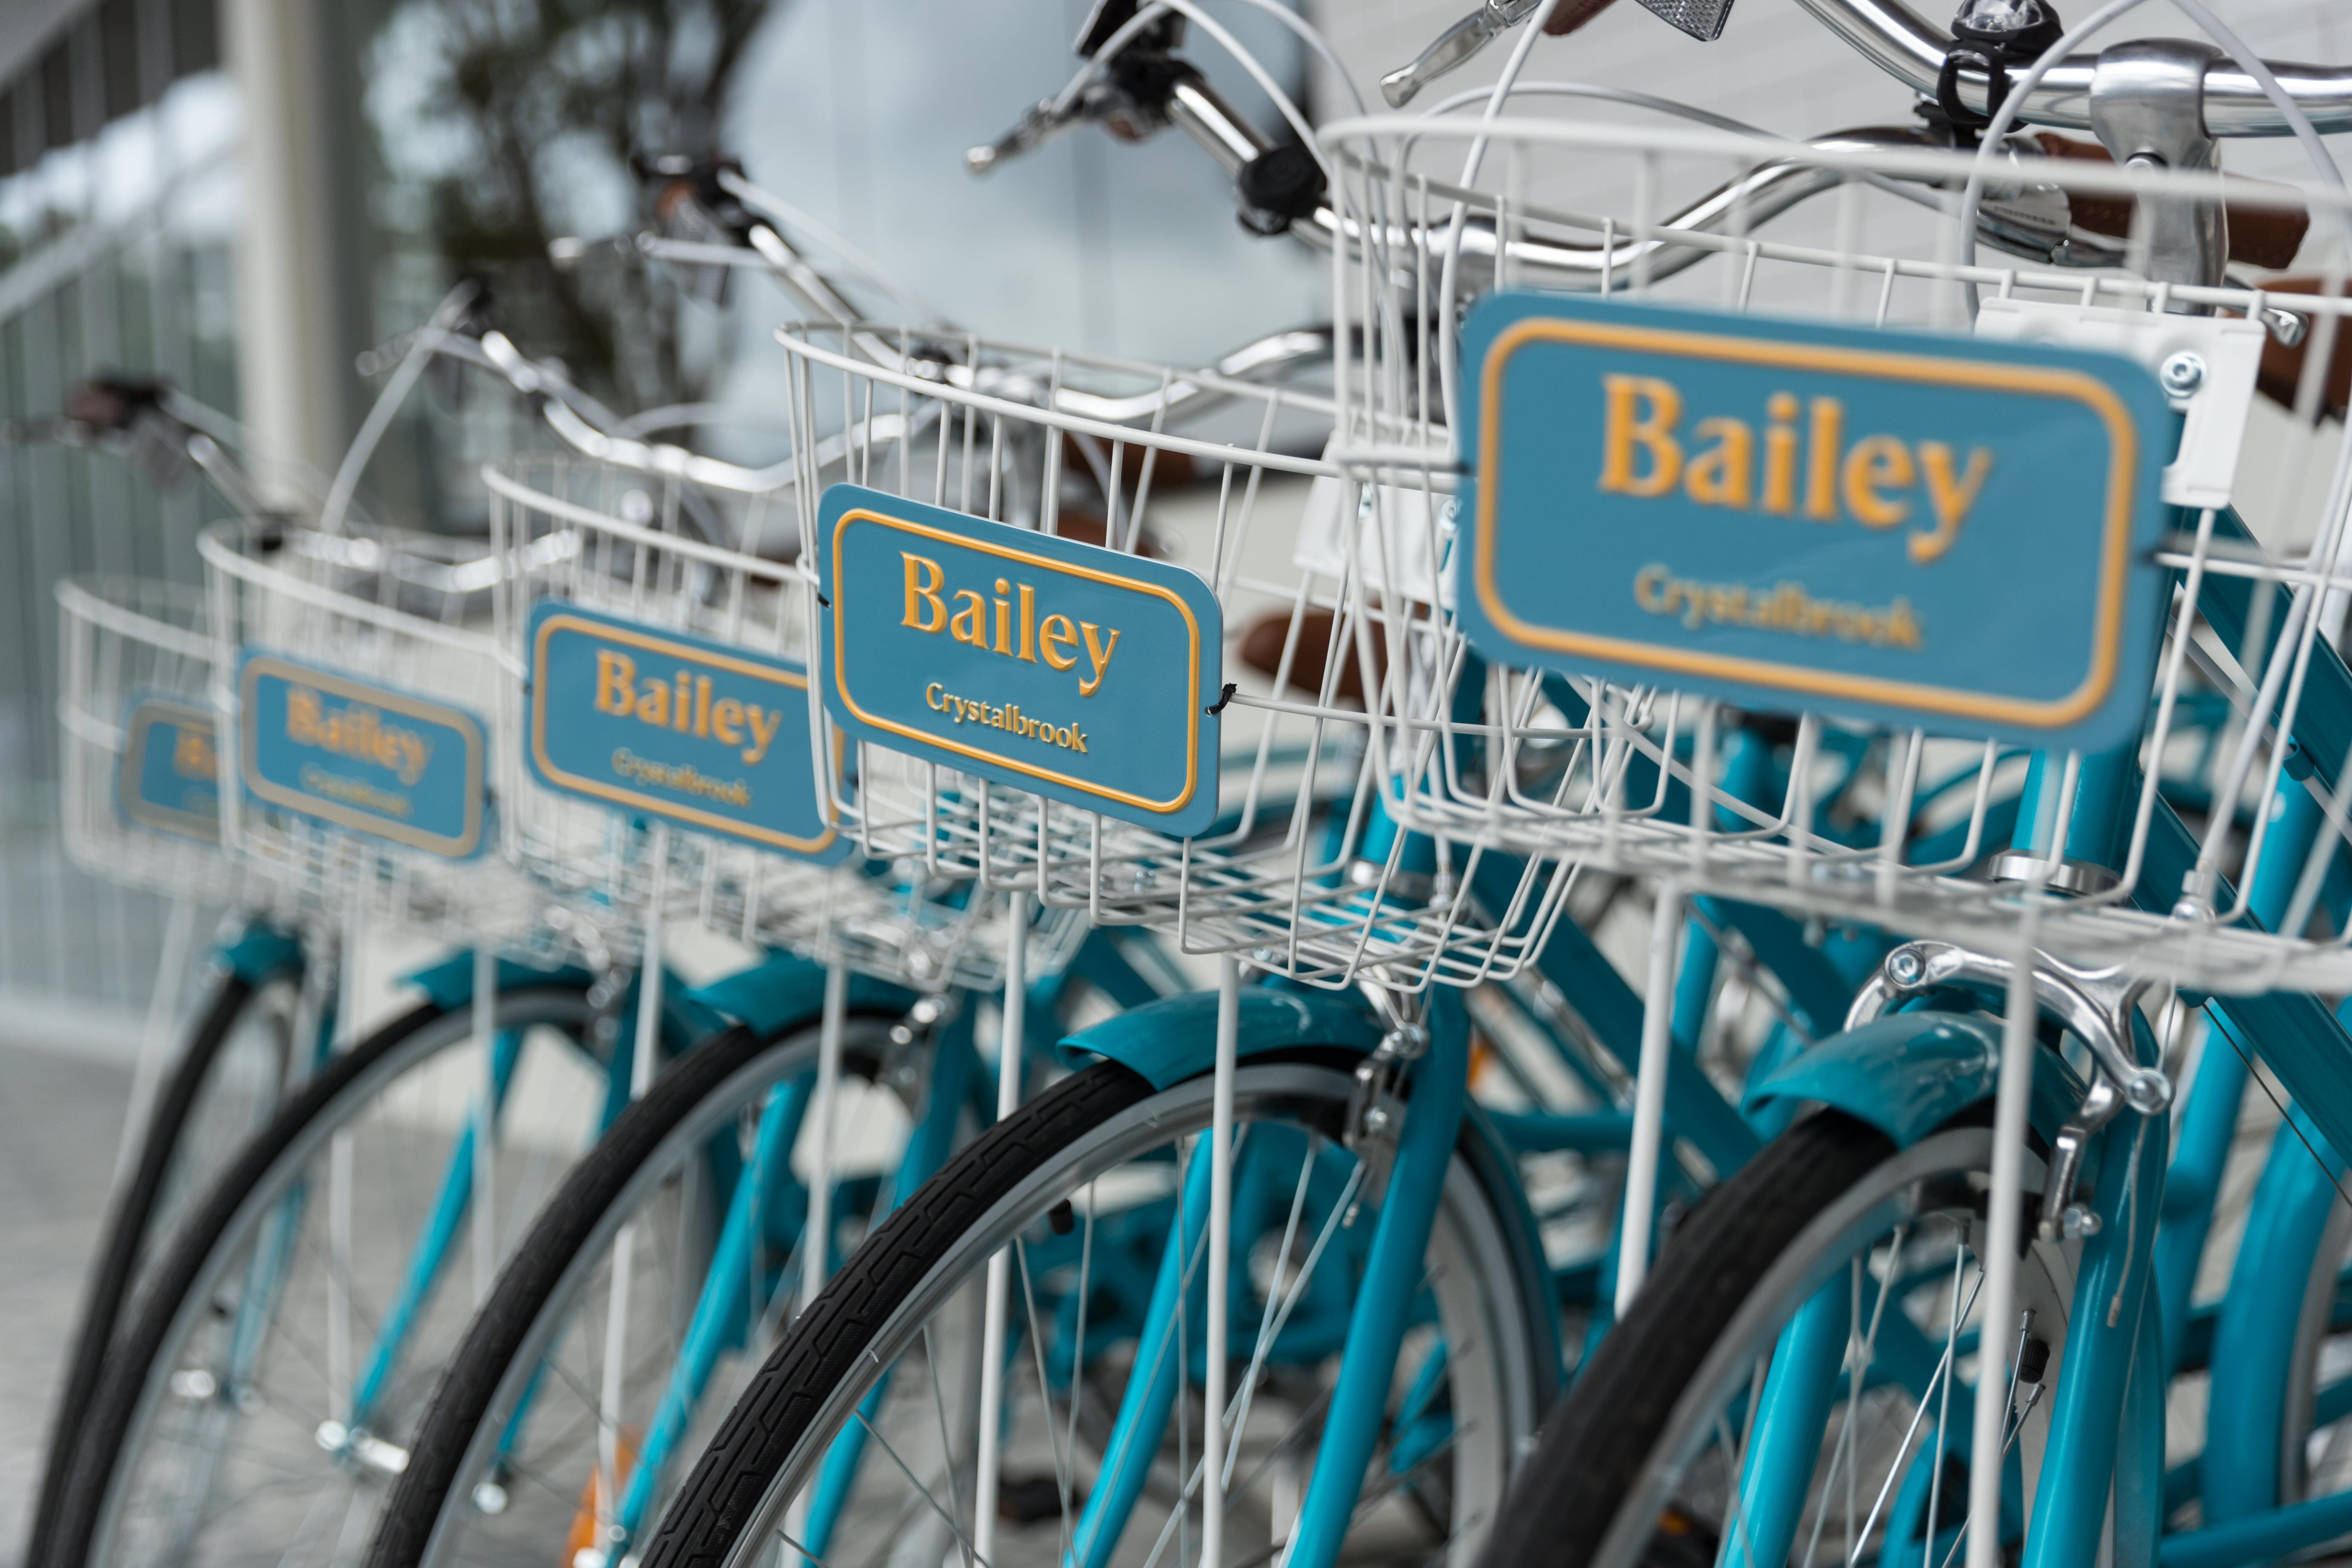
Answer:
[28,376,552,1561]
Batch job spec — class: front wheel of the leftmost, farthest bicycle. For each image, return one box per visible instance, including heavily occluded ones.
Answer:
[24,973,301,1563]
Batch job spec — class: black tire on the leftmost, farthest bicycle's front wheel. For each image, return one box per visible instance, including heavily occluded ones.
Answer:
[24,973,294,1563]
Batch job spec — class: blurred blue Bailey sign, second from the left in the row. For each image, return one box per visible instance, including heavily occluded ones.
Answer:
[238,651,489,861]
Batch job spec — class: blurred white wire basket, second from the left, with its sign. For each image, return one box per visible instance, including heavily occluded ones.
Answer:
[198,522,606,968]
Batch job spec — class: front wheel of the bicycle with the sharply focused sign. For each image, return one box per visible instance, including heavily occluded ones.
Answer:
[642,1051,1557,1568]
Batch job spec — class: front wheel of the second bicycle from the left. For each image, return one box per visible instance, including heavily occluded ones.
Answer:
[49,978,628,1568]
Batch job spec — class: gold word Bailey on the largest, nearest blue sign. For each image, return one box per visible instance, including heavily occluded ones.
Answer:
[1599,376,1992,567]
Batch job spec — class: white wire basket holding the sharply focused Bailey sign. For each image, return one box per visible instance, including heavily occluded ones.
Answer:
[778,325,1574,992]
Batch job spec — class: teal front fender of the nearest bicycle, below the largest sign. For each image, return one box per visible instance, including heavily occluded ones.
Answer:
[1743,1013,2084,1147]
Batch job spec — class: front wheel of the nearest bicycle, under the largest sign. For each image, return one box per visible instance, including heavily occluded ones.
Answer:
[1479,1112,2096,1568]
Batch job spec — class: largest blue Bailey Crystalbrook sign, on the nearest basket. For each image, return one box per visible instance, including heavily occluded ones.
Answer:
[1458,294,2176,750]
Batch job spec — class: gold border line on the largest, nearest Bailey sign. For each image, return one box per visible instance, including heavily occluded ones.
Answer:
[1477,317,2138,729]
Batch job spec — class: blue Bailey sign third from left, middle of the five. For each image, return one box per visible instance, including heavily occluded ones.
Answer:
[529,600,851,863]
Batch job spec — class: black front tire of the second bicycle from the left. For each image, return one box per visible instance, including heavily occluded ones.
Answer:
[49,980,593,1568]
